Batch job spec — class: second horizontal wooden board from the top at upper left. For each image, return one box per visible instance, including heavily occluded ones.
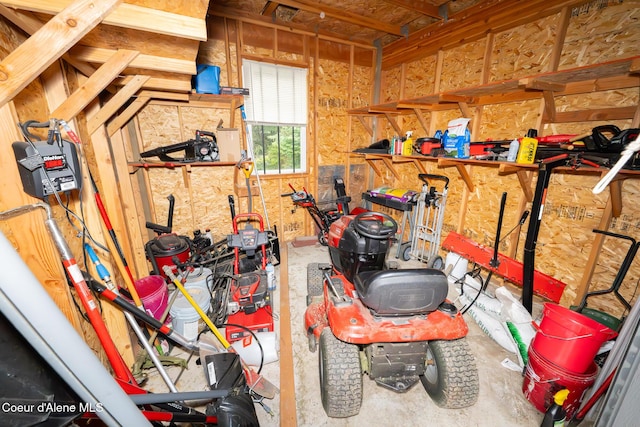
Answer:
[69,45,197,76]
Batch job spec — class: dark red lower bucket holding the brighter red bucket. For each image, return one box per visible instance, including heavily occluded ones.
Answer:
[522,347,598,420]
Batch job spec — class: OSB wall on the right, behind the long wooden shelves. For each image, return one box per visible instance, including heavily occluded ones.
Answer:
[368,1,640,315]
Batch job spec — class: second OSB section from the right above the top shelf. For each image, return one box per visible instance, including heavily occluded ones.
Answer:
[488,15,558,82]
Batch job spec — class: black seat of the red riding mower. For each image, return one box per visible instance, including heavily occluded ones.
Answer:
[354,268,449,316]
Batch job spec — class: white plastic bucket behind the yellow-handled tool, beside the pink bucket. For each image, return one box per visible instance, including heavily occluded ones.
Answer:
[169,285,211,341]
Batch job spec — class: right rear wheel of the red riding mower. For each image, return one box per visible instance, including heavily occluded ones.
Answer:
[420,338,480,409]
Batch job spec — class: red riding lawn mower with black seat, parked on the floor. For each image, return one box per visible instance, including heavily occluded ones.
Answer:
[305,212,479,418]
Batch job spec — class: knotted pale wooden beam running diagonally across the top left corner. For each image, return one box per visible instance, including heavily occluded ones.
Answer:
[0,0,122,106]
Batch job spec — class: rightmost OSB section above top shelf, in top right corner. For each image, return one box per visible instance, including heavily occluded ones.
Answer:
[559,0,640,69]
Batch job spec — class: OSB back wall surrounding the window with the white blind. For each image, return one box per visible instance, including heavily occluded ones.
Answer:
[138,26,373,241]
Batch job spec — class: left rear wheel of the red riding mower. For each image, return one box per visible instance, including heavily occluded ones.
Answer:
[318,328,362,418]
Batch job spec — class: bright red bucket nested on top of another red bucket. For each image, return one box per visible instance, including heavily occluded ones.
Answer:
[530,303,618,374]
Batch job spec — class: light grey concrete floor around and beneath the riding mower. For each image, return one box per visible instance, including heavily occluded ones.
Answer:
[149,244,543,427]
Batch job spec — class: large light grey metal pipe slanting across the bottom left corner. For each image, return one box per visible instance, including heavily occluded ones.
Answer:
[0,231,151,427]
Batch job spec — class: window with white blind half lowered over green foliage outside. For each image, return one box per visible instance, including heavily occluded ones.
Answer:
[242,60,308,174]
